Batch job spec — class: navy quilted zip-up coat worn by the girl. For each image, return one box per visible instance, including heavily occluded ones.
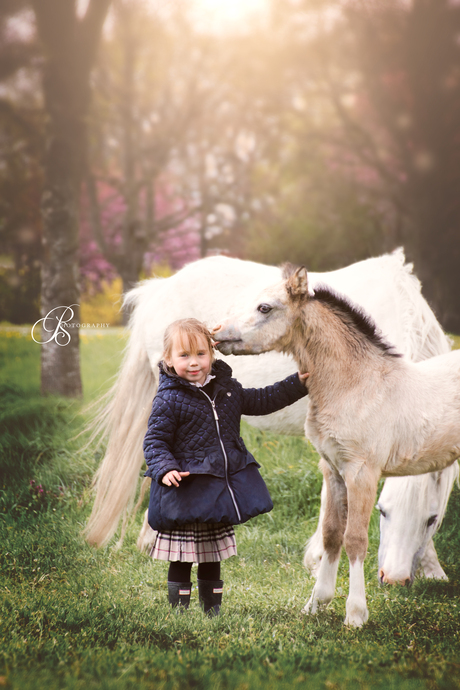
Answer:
[144,360,307,530]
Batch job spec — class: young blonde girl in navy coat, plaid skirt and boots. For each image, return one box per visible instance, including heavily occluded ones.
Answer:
[144,319,308,615]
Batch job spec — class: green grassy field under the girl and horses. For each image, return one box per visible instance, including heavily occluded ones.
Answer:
[0,332,460,690]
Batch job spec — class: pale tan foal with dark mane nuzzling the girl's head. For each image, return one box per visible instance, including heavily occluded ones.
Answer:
[215,267,460,627]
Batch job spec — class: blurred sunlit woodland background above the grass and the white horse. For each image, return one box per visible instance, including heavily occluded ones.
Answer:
[0,0,460,333]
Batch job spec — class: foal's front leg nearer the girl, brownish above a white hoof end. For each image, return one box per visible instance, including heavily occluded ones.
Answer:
[303,460,347,613]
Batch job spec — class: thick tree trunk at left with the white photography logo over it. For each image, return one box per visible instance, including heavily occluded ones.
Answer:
[33,0,110,397]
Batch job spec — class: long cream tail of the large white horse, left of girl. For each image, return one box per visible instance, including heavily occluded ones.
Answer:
[84,287,158,546]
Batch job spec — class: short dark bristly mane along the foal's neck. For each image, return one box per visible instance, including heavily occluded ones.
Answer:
[311,285,401,357]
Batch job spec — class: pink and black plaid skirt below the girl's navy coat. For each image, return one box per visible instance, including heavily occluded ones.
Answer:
[150,522,236,563]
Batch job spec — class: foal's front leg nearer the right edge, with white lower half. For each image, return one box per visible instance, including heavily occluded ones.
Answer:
[345,464,379,628]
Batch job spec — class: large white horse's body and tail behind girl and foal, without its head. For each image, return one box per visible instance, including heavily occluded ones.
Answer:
[86,250,450,574]
